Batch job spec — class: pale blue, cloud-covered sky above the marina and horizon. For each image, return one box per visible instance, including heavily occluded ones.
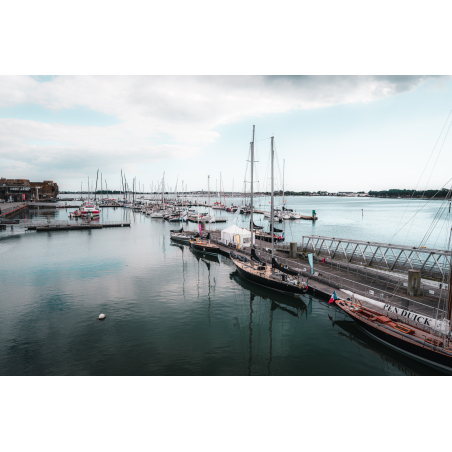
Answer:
[0,75,452,192]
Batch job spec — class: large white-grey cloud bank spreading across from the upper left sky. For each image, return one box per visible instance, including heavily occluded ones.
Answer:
[0,76,446,185]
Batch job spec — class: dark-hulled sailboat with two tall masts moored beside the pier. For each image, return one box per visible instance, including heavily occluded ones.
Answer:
[230,126,307,296]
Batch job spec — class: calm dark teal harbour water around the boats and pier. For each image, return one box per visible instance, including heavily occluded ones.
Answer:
[0,197,449,375]
